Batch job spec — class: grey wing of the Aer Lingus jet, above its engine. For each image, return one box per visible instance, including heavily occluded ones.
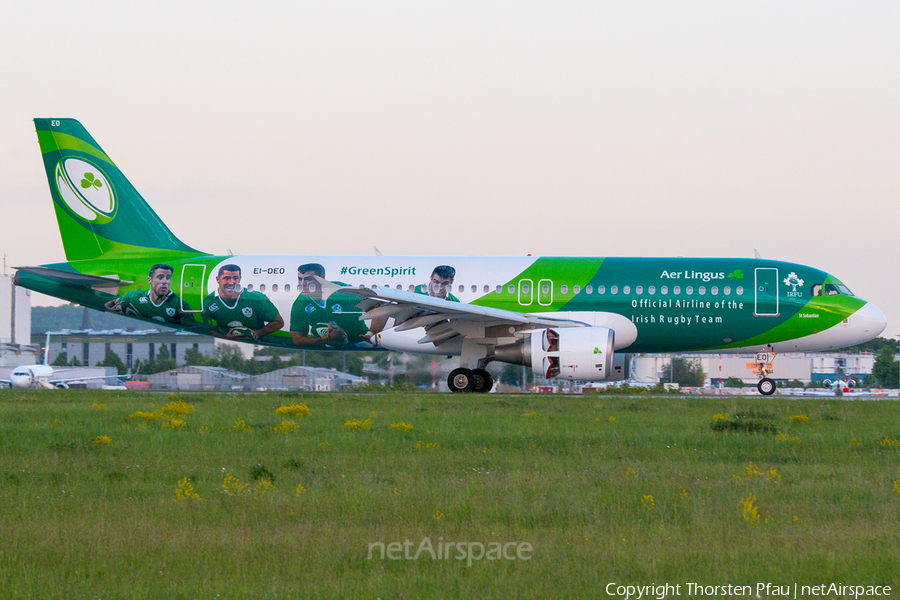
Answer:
[326,278,588,346]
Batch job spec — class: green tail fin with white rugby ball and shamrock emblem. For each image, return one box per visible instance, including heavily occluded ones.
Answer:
[34,119,199,261]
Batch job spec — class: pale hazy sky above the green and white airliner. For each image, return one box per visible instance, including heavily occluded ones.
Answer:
[0,1,900,335]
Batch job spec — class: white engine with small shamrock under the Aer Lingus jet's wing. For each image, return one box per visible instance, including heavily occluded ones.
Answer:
[494,327,626,381]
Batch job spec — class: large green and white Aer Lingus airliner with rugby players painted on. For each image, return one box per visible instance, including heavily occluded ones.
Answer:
[16,119,886,395]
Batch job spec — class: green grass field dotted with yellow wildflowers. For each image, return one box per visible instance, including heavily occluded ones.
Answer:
[0,390,900,599]
